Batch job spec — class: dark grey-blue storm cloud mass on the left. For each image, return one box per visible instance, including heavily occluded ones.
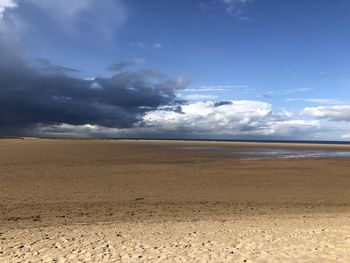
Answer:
[0,35,187,134]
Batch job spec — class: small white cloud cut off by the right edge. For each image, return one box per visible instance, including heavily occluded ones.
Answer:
[301,105,350,122]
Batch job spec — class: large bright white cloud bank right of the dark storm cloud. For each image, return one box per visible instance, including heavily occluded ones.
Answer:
[143,100,319,136]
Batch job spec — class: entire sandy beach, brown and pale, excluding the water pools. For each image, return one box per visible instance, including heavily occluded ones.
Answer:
[0,139,350,262]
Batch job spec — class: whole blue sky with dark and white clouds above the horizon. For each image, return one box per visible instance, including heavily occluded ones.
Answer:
[0,0,350,141]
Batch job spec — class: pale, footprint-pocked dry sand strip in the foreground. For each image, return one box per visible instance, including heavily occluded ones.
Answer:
[1,215,350,262]
